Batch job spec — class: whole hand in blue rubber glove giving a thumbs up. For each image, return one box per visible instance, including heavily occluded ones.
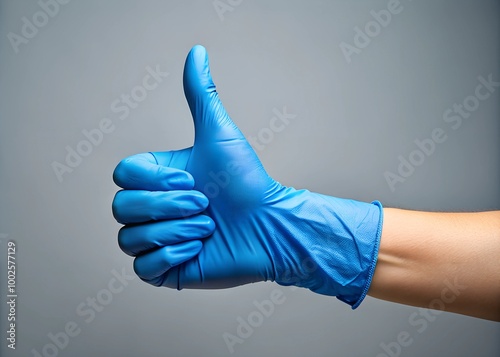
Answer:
[113,46,382,308]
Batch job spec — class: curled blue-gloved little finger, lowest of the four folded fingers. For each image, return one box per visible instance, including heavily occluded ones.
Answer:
[134,240,203,286]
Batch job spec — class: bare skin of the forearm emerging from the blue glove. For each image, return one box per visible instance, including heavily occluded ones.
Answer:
[368,208,500,321]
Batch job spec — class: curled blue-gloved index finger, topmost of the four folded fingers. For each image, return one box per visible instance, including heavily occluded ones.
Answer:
[113,152,194,191]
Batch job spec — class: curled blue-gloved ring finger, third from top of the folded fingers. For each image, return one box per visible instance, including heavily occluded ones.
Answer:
[118,215,215,256]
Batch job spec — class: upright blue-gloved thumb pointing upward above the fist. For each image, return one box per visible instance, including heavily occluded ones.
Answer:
[183,45,243,144]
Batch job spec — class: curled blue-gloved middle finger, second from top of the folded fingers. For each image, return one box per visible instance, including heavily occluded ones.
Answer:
[112,190,208,224]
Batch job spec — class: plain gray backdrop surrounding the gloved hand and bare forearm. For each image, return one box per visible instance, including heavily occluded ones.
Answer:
[0,0,500,357]
